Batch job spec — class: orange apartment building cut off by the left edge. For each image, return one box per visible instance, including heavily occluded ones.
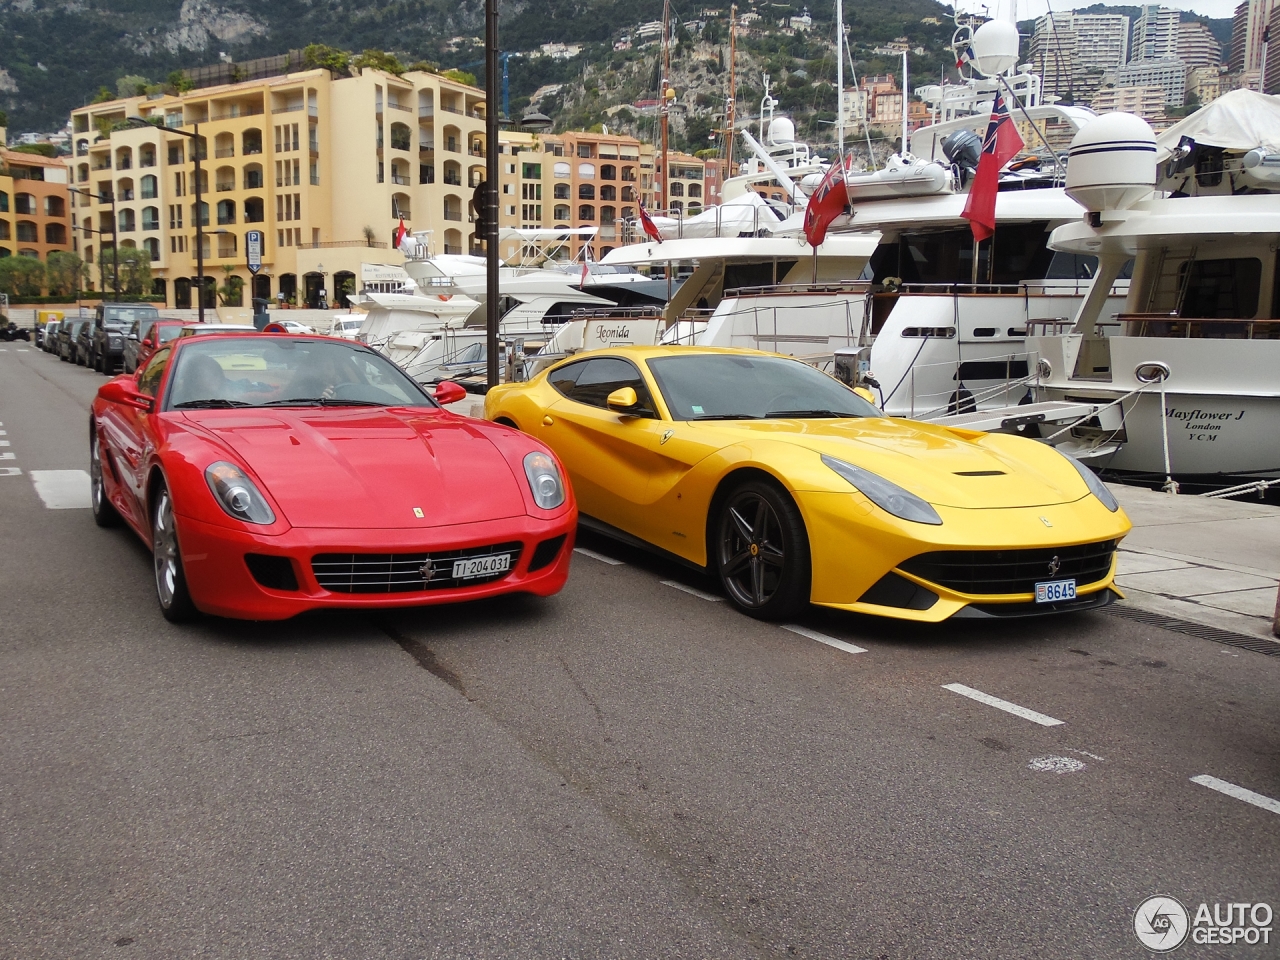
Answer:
[0,146,72,260]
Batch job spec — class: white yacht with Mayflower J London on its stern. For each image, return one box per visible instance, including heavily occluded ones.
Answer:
[1028,97,1280,489]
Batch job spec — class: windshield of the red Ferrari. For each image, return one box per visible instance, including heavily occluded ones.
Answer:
[165,335,436,410]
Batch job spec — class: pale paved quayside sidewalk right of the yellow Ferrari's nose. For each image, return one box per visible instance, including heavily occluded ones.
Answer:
[1108,484,1280,644]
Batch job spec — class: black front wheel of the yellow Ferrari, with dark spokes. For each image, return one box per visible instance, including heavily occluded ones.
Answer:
[712,480,812,620]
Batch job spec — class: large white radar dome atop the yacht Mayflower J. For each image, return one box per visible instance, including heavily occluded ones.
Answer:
[1066,114,1156,212]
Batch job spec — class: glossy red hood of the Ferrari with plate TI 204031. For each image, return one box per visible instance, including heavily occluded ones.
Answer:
[186,407,525,529]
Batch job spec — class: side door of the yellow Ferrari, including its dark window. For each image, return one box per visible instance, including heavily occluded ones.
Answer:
[538,357,669,540]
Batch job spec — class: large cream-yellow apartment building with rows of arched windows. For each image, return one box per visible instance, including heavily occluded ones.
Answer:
[72,63,488,307]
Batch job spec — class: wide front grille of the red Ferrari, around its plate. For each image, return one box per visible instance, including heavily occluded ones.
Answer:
[311,540,522,594]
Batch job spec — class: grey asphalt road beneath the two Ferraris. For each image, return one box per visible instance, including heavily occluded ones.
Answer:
[0,343,1280,960]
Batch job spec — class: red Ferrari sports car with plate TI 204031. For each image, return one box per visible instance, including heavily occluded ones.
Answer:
[90,333,577,621]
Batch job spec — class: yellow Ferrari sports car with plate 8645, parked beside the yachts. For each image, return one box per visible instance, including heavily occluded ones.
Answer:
[485,347,1130,622]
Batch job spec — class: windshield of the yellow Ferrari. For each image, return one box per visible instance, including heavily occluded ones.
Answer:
[648,353,883,420]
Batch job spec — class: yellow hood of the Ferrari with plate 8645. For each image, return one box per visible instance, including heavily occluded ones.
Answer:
[690,417,1089,509]
